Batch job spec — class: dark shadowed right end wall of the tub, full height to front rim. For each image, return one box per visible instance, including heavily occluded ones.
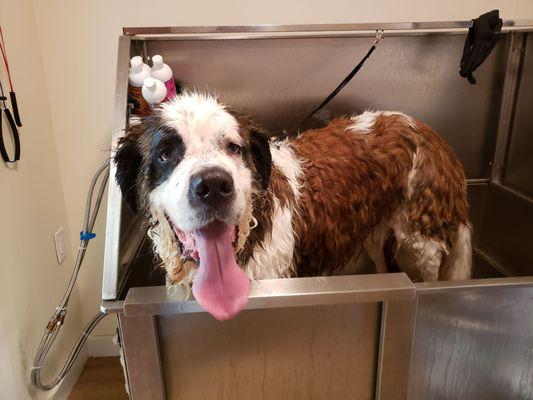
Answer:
[478,33,533,276]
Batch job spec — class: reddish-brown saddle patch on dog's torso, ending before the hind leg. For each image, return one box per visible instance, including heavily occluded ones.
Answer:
[292,119,414,275]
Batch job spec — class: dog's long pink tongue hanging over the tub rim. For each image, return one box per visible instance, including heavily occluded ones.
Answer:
[192,221,250,320]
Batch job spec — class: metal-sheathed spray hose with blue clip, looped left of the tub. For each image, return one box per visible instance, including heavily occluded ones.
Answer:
[31,161,109,390]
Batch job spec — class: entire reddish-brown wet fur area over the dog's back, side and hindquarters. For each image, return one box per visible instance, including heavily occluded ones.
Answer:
[291,115,468,276]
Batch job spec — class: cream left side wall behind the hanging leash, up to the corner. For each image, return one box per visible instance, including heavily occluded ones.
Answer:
[0,0,83,400]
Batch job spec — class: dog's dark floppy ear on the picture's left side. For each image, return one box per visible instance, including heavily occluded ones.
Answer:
[114,135,142,214]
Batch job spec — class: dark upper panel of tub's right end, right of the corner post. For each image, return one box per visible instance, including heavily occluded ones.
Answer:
[504,34,533,198]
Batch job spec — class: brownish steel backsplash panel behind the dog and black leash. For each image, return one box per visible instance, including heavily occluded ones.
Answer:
[147,35,508,178]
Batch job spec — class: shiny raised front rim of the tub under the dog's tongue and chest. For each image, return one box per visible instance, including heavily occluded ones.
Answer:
[124,273,414,316]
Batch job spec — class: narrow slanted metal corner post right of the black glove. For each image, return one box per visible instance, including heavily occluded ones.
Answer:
[492,33,525,183]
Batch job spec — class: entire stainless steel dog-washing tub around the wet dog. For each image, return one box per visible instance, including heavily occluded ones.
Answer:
[102,21,533,399]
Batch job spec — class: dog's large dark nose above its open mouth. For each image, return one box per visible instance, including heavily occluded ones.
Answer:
[189,167,235,206]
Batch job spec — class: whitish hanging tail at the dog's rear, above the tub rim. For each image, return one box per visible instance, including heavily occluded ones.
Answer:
[439,224,472,281]
